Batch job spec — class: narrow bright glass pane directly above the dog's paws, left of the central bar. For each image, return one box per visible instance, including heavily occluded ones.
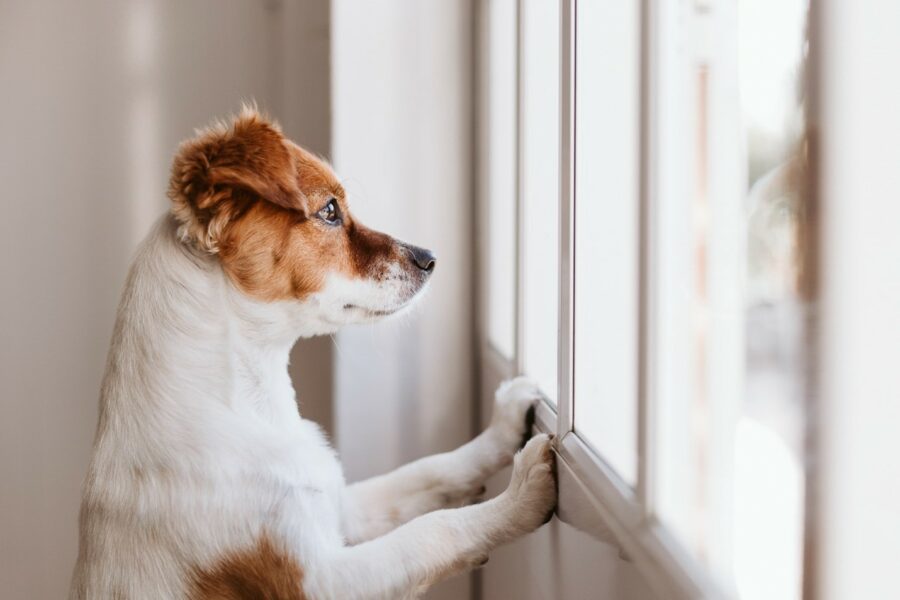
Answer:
[520,0,560,401]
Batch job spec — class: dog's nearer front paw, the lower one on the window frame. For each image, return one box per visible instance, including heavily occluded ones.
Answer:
[503,433,557,533]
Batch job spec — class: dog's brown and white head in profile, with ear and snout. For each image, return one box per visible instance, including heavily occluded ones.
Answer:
[169,108,435,332]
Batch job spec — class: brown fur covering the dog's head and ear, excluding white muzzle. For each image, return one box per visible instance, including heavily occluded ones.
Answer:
[169,108,402,301]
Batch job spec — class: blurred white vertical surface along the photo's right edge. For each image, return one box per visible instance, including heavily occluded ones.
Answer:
[808,0,900,600]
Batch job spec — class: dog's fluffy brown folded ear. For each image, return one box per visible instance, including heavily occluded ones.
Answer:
[169,106,308,252]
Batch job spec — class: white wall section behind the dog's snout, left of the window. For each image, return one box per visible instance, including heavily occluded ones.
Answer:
[332,0,474,598]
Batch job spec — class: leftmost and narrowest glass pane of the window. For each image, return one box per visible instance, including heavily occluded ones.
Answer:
[487,0,517,358]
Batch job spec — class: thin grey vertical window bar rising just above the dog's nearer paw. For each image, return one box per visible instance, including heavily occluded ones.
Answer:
[557,0,577,439]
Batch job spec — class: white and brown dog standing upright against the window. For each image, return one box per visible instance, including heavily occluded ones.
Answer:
[70,107,556,600]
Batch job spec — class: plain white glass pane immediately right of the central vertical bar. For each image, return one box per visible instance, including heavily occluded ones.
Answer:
[574,1,640,484]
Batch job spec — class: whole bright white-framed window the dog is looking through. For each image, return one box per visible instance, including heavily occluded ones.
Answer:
[483,0,812,600]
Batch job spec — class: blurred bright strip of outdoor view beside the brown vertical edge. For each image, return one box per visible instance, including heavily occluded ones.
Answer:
[734,0,809,600]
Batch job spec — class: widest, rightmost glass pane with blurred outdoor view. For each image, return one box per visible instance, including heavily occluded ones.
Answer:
[653,0,809,600]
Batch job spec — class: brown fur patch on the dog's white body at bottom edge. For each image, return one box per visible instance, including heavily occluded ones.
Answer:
[189,535,306,600]
